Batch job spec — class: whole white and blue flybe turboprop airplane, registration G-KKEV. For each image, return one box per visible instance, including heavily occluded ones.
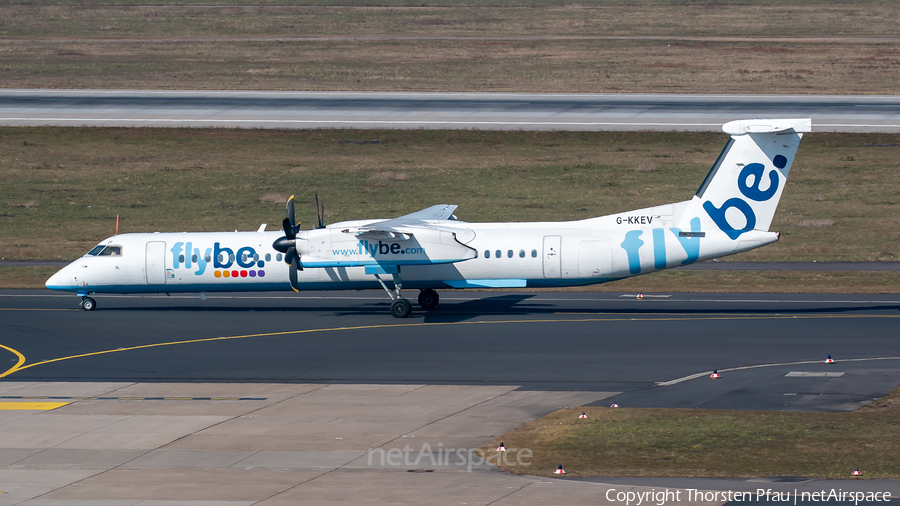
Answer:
[46,119,812,318]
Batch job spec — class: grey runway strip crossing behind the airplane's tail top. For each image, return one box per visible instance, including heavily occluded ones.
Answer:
[0,89,900,133]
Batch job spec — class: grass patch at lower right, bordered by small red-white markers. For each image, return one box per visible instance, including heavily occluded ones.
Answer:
[483,388,900,478]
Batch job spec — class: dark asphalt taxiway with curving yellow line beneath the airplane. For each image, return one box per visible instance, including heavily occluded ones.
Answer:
[0,290,900,411]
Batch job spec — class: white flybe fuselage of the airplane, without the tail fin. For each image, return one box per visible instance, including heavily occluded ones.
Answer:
[47,201,778,294]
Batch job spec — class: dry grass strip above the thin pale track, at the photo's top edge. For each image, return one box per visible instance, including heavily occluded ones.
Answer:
[0,0,900,38]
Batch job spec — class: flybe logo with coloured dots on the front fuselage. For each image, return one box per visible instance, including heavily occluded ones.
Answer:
[169,242,266,278]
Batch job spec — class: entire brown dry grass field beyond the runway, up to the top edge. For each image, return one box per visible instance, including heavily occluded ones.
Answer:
[0,0,900,94]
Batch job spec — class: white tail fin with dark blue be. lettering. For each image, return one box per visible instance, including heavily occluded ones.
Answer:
[680,119,812,240]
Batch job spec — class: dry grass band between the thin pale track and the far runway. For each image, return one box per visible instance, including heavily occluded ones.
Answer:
[0,40,900,94]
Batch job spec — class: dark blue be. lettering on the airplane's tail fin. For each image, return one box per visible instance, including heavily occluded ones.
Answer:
[703,155,787,240]
